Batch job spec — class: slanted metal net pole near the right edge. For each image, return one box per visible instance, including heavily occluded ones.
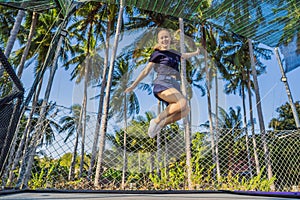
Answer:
[275,47,300,129]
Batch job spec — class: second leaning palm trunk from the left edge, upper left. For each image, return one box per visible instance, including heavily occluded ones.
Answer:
[17,12,38,78]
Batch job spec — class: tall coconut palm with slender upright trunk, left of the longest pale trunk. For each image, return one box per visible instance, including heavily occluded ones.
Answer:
[66,2,103,177]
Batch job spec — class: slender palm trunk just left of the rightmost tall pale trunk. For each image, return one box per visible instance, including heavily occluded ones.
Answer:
[247,70,260,174]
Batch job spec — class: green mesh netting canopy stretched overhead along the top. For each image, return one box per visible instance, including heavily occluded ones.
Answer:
[0,0,300,72]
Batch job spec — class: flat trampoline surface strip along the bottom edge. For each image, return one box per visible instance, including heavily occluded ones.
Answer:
[0,190,300,200]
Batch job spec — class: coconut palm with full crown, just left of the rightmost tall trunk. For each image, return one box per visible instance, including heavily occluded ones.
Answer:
[222,29,271,177]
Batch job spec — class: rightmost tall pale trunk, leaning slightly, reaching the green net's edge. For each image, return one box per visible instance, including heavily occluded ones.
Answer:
[248,39,275,190]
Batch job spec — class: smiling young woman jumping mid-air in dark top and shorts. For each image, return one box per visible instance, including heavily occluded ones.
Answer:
[125,29,200,138]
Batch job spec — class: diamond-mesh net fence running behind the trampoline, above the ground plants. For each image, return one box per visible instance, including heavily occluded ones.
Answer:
[1,104,300,191]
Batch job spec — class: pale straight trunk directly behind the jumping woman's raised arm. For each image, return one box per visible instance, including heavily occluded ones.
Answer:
[179,18,193,190]
